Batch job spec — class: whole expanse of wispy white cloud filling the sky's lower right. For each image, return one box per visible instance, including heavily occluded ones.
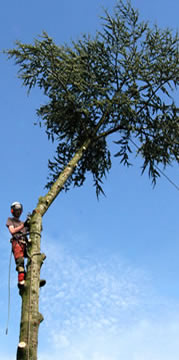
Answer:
[37,232,179,360]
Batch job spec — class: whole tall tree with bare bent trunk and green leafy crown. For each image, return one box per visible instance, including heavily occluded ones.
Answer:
[6,0,179,360]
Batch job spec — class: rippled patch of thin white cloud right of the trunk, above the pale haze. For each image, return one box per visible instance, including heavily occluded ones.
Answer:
[41,240,150,339]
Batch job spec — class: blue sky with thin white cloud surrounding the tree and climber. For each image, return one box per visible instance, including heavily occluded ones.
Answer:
[0,0,179,360]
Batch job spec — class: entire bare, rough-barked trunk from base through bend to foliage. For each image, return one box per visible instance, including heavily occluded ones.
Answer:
[16,139,91,360]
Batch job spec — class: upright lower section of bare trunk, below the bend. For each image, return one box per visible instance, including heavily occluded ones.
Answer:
[17,213,45,360]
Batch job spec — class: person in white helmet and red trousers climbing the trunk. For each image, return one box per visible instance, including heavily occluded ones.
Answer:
[6,201,29,288]
